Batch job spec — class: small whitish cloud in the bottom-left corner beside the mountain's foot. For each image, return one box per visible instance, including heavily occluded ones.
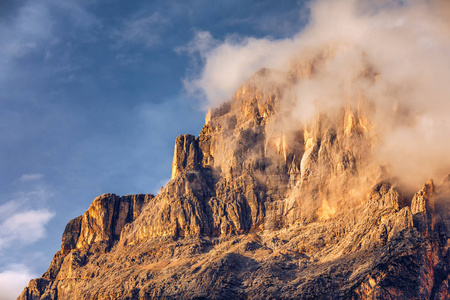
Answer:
[0,264,38,300]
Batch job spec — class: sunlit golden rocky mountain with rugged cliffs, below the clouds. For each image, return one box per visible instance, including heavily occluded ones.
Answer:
[19,64,450,299]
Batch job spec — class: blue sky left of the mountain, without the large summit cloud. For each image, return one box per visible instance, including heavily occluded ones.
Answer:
[0,0,308,299]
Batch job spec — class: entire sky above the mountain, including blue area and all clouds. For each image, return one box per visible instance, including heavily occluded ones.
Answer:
[4,0,450,300]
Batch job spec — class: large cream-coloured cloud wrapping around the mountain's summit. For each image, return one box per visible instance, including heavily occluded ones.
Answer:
[186,0,450,191]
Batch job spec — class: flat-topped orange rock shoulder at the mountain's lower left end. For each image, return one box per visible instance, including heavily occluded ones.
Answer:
[21,194,154,299]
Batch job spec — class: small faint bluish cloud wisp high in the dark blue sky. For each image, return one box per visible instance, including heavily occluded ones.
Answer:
[112,12,170,48]
